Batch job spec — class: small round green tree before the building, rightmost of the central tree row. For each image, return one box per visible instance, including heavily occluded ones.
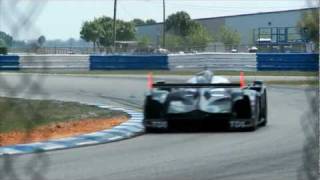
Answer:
[218,26,241,48]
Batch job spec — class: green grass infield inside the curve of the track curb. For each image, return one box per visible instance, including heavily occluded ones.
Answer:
[0,97,124,133]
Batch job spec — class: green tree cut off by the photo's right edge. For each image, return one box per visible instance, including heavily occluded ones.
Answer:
[297,9,319,43]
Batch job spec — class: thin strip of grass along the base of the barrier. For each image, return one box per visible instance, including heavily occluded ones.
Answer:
[6,70,318,76]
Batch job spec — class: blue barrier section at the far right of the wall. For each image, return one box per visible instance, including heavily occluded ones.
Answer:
[257,53,319,71]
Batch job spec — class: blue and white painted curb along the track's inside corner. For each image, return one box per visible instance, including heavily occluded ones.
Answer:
[0,104,144,157]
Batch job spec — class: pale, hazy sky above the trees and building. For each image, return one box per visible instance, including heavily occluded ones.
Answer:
[0,0,317,40]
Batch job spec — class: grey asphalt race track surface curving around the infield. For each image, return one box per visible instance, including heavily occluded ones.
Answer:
[0,75,317,180]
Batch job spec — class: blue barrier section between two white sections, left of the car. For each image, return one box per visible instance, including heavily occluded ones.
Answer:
[90,55,168,70]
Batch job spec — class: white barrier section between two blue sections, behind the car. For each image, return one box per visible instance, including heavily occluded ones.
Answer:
[168,53,257,71]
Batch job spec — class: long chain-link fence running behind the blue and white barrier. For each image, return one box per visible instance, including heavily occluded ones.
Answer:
[9,43,315,54]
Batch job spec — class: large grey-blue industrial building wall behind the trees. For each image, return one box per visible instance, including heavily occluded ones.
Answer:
[137,8,316,51]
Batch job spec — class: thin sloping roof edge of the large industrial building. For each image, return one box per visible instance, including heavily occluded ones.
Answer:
[137,7,318,27]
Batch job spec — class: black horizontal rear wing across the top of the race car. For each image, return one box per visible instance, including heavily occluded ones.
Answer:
[152,82,240,89]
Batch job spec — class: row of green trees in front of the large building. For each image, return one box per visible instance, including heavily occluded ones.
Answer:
[80,11,240,51]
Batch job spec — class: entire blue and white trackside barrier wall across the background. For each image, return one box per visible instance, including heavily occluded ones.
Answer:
[0,53,319,71]
